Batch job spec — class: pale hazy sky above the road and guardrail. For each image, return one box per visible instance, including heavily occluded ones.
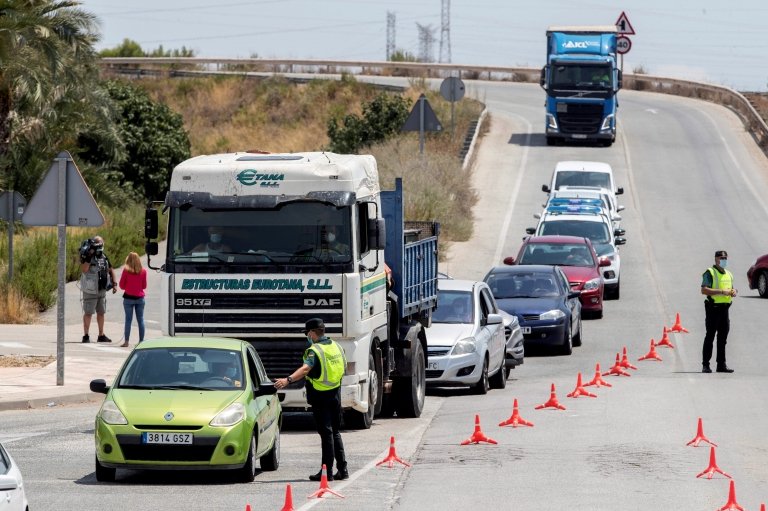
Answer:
[81,0,768,91]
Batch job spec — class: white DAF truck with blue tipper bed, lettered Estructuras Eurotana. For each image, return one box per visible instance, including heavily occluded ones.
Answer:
[145,152,439,428]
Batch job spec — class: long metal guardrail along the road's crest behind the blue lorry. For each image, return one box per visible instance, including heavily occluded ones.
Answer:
[101,57,768,155]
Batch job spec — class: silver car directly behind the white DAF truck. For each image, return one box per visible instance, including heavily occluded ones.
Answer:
[426,279,510,394]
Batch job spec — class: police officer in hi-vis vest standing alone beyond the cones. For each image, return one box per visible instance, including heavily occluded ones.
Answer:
[701,250,738,373]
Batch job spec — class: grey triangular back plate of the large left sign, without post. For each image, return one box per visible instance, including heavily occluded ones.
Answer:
[21,151,104,227]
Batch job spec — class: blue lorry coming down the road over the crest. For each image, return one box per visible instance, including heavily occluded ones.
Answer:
[540,25,621,146]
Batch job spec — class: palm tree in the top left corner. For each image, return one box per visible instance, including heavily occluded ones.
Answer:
[0,0,102,191]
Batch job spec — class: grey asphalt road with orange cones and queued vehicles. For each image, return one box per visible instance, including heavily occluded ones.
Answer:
[0,82,768,511]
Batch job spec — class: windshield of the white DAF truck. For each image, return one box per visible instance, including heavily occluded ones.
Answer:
[168,202,352,266]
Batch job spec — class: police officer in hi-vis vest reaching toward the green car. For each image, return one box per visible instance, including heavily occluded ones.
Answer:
[275,318,349,481]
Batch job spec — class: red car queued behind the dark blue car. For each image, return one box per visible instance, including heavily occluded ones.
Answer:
[504,236,611,318]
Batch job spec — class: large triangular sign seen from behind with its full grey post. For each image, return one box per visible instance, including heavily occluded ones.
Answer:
[21,151,104,385]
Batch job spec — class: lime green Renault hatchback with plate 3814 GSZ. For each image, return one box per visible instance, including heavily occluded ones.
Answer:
[91,337,283,482]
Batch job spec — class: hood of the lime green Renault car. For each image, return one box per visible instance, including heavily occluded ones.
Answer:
[112,389,245,426]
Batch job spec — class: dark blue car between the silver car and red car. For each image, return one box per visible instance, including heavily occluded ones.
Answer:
[483,265,582,355]
